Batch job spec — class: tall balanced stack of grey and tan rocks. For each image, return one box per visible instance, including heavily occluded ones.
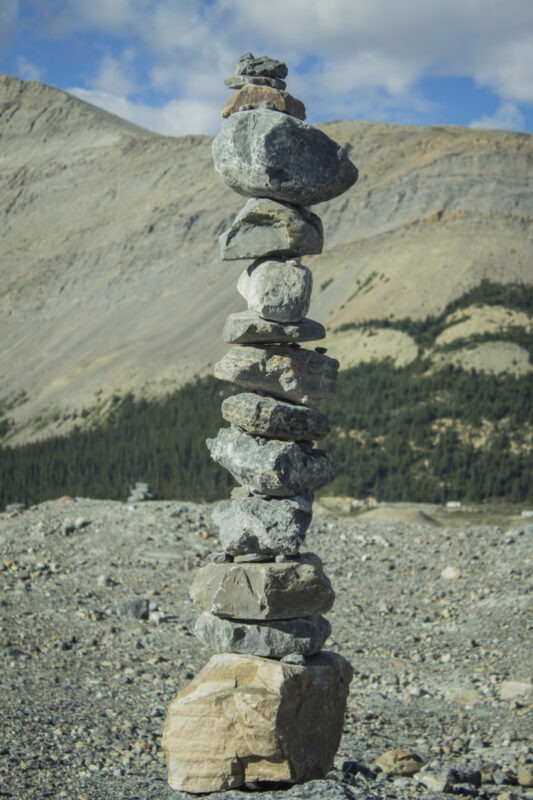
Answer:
[163,53,357,793]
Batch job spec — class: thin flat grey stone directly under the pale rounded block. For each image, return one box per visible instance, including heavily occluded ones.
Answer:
[222,311,326,344]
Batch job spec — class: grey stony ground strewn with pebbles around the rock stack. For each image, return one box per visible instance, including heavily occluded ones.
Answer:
[0,498,533,800]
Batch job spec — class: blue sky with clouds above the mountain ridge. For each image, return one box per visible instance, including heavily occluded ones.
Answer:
[0,0,533,136]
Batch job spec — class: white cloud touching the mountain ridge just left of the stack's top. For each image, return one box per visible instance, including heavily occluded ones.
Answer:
[67,88,220,136]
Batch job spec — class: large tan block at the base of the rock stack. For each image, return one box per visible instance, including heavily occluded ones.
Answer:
[163,653,353,800]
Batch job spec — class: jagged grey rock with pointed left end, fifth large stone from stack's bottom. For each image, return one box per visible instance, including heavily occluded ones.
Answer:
[206,427,336,497]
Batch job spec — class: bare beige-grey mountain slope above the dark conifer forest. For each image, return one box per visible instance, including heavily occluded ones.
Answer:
[0,76,533,443]
